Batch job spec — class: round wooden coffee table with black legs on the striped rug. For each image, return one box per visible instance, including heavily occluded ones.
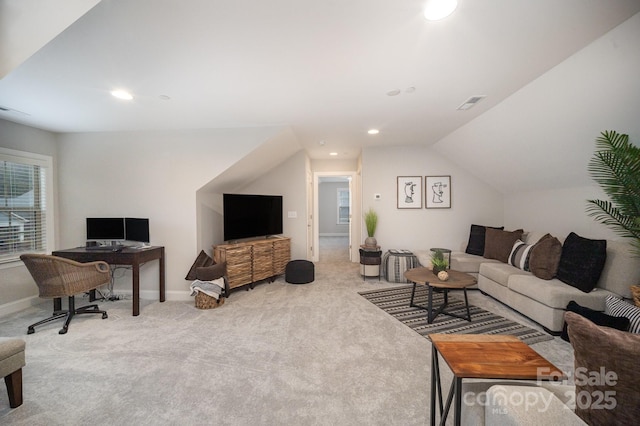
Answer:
[404,268,476,324]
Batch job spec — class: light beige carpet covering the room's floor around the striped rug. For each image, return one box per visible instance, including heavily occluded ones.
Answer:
[0,240,573,426]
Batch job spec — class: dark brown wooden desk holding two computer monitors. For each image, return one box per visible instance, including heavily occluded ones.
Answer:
[51,246,165,317]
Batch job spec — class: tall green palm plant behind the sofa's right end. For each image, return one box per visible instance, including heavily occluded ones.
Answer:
[587,131,640,306]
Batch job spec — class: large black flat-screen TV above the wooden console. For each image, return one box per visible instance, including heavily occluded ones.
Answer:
[222,194,282,241]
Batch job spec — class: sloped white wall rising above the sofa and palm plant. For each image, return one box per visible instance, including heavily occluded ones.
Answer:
[434,14,640,238]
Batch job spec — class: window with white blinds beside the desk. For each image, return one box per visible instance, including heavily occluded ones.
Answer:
[0,150,51,263]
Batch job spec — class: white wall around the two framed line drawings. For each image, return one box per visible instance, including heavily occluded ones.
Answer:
[354,146,503,255]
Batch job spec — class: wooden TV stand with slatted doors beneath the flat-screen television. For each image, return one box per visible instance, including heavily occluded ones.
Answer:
[213,237,291,289]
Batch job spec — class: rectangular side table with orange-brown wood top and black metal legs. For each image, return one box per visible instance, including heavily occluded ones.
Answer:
[429,334,567,425]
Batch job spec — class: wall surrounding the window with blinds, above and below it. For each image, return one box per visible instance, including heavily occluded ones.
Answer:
[0,120,58,315]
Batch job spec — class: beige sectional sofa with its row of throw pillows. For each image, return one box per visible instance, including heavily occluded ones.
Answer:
[416,225,640,334]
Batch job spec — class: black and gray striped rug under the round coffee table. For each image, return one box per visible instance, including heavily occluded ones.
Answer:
[359,285,553,345]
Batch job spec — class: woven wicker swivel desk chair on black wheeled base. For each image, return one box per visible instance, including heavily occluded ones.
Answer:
[20,254,111,334]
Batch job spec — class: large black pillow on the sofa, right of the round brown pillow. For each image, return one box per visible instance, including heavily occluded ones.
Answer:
[556,232,607,293]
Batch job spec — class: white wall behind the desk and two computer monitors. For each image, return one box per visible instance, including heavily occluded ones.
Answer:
[58,128,282,299]
